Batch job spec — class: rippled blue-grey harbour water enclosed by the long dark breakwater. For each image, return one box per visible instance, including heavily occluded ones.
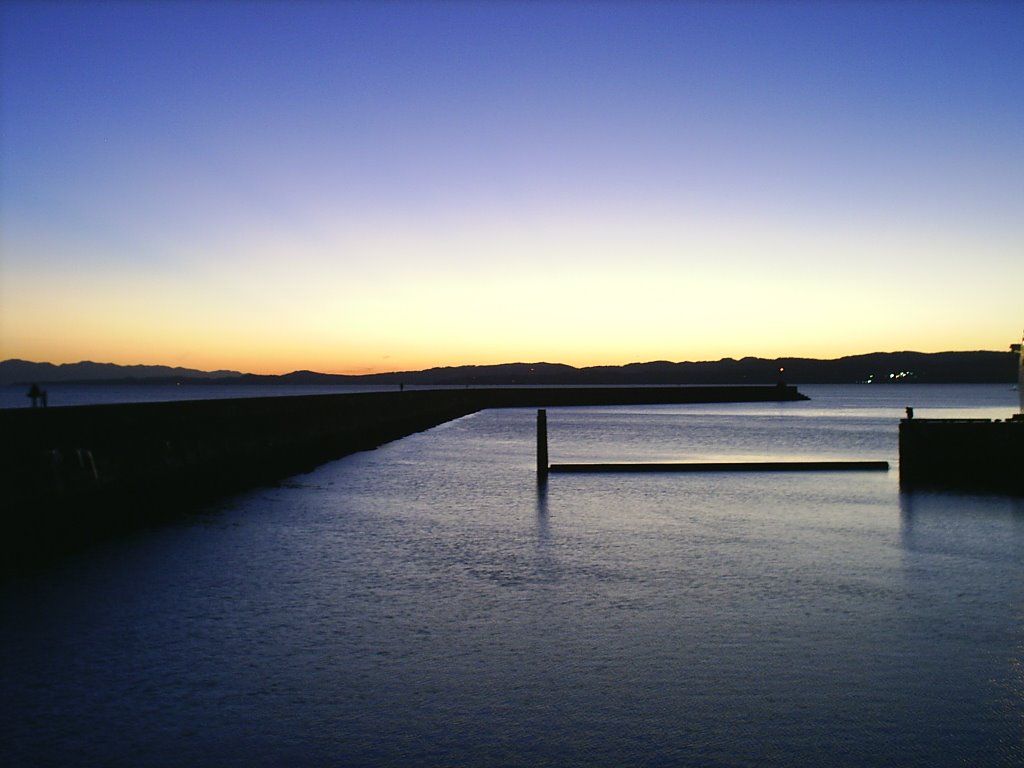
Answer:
[0,385,1024,767]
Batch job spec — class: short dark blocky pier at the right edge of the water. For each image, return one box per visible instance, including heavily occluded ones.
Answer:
[899,418,1024,495]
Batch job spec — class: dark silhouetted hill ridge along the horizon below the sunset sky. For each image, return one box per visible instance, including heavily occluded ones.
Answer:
[0,351,1018,386]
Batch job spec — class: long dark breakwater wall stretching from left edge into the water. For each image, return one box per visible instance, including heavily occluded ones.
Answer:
[0,386,805,570]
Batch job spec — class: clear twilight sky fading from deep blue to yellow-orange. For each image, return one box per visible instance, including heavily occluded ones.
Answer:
[0,0,1024,374]
